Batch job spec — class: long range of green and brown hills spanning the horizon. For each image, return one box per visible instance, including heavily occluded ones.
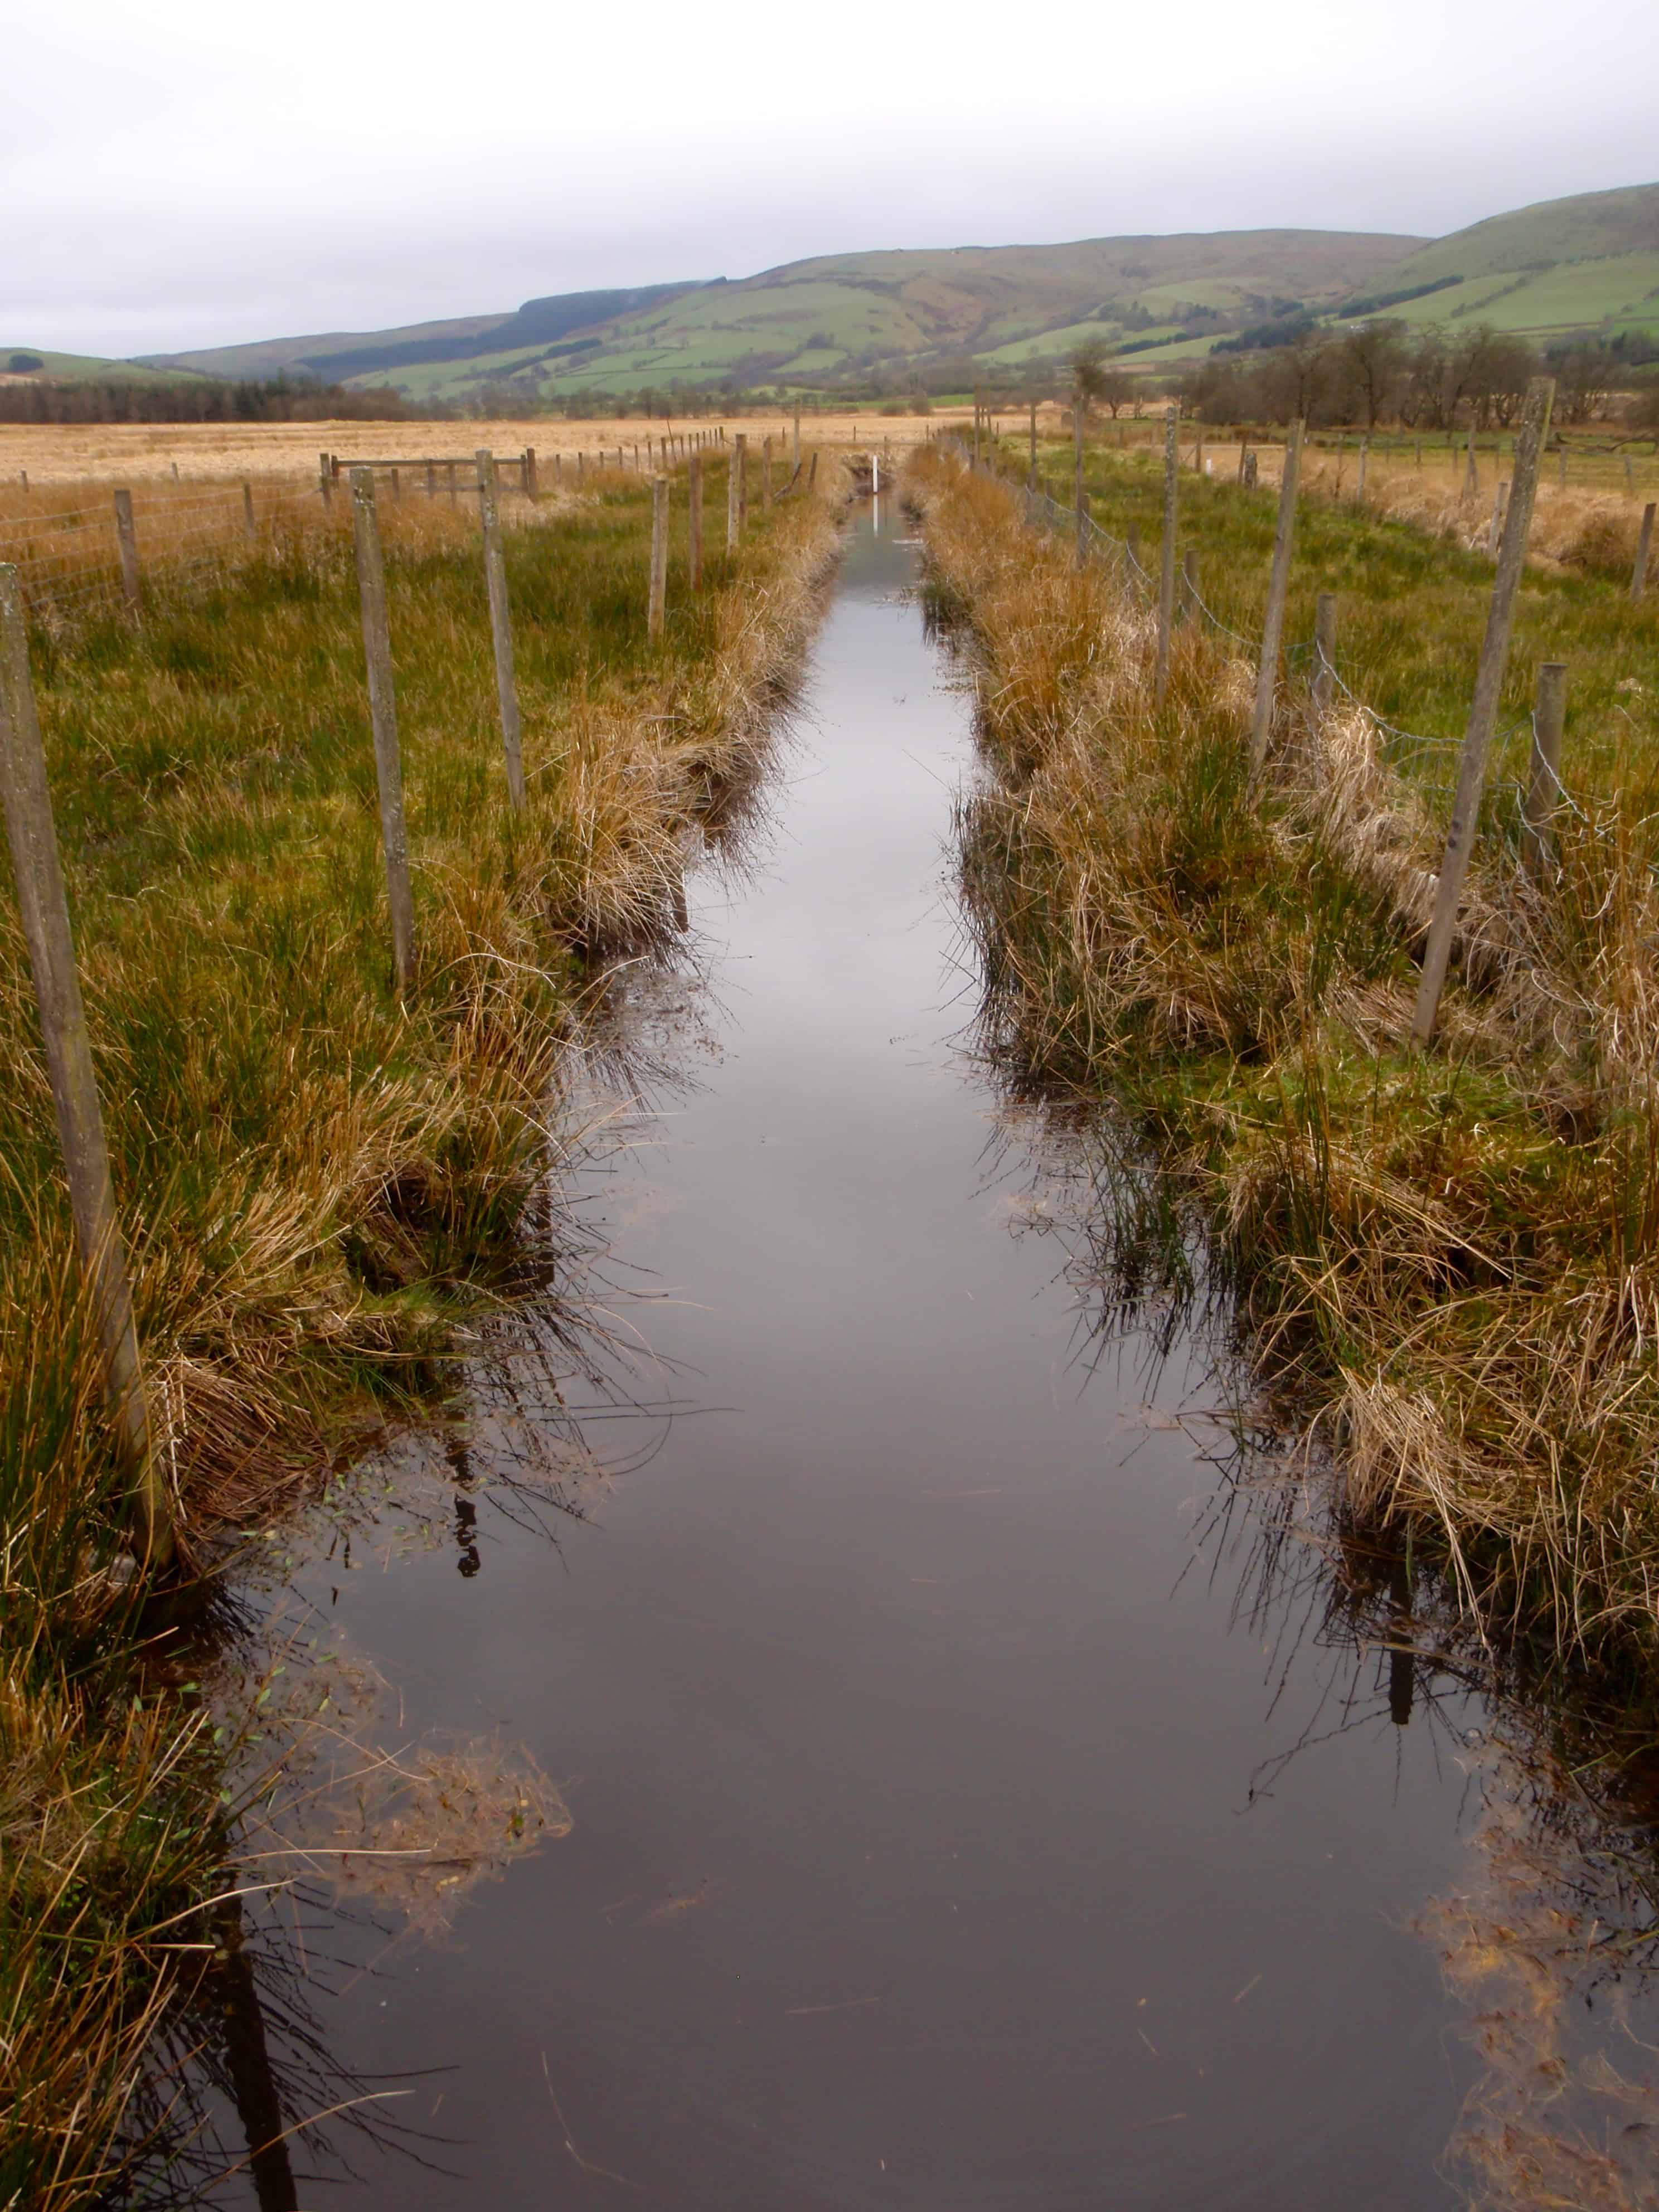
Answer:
[22,183,1659,405]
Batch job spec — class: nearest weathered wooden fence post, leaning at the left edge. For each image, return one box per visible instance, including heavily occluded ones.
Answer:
[0,562,173,1566]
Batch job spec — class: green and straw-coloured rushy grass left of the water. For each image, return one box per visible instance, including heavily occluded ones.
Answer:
[0,449,838,2205]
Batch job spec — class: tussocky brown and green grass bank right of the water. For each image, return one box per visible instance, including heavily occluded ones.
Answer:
[911,444,1659,1663]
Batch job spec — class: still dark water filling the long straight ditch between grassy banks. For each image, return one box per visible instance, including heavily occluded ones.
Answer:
[201,513,1504,2212]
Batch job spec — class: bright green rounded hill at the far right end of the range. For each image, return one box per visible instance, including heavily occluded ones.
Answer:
[1336,183,1659,338]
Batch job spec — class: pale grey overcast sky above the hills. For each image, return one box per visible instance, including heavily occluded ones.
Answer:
[0,0,1659,354]
